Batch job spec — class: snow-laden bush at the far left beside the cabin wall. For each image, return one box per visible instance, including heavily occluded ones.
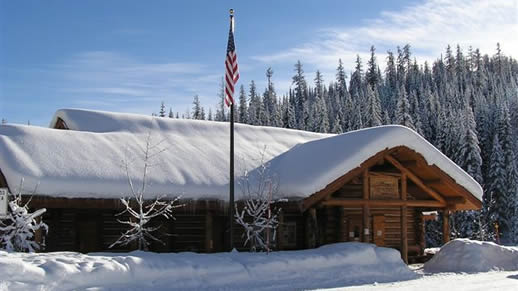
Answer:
[0,179,48,253]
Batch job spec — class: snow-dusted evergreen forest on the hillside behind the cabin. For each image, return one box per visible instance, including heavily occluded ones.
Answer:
[154,44,518,246]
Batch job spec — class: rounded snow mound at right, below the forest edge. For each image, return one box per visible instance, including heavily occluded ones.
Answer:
[424,239,518,273]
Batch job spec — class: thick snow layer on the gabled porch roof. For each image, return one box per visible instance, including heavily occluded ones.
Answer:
[258,125,482,200]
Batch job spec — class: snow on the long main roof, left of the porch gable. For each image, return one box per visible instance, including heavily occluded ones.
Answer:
[0,110,328,199]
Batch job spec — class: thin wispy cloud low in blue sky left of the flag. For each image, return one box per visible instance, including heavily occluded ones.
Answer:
[50,51,221,114]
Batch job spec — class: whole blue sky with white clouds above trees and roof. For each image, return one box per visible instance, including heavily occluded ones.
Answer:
[0,0,518,126]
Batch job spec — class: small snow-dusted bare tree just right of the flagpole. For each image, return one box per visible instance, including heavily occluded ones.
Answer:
[234,150,281,252]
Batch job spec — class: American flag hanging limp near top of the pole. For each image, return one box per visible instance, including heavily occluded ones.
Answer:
[225,16,239,107]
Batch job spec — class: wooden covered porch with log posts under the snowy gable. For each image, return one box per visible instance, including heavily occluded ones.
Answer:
[301,146,481,263]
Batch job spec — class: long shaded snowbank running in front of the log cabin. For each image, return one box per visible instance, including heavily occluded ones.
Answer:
[0,243,418,290]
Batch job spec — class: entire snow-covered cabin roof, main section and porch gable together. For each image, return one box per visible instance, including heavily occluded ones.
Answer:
[0,109,482,204]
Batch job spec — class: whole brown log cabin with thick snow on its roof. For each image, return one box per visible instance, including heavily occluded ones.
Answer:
[0,109,482,262]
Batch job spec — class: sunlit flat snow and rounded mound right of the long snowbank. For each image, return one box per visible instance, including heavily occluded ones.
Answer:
[319,239,518,291]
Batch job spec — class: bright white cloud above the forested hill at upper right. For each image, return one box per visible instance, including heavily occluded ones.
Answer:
[254,0,518,72]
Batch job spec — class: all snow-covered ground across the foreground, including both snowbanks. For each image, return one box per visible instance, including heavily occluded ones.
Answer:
[0,240,518,291]
